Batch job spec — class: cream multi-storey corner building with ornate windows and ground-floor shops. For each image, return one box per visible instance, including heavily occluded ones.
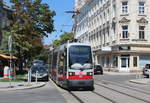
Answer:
[73,0,150,72]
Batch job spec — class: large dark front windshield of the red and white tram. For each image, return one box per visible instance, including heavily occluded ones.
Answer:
[69,46,92,69]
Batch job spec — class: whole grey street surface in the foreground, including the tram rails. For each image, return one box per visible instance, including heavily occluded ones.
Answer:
[0,73,150,103]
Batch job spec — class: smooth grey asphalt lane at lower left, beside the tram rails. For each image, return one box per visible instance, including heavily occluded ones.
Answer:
[0,82,66,103]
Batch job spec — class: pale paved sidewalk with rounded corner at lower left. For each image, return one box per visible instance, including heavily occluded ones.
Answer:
[0,82,46,91]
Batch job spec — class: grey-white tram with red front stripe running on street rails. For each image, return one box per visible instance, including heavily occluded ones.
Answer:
[50,43,94,90]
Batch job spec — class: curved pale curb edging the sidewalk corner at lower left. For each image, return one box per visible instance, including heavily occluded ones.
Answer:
[0,83,46,91]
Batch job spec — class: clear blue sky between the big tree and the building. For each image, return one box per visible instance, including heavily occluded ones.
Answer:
[3,0,74,44]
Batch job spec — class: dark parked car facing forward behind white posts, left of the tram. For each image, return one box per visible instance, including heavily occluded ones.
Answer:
[31,65,49,81]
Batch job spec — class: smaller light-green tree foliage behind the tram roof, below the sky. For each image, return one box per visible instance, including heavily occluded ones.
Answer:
[53,32,74,48]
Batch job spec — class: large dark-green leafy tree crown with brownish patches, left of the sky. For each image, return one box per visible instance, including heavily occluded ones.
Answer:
[11,0,55,70]
